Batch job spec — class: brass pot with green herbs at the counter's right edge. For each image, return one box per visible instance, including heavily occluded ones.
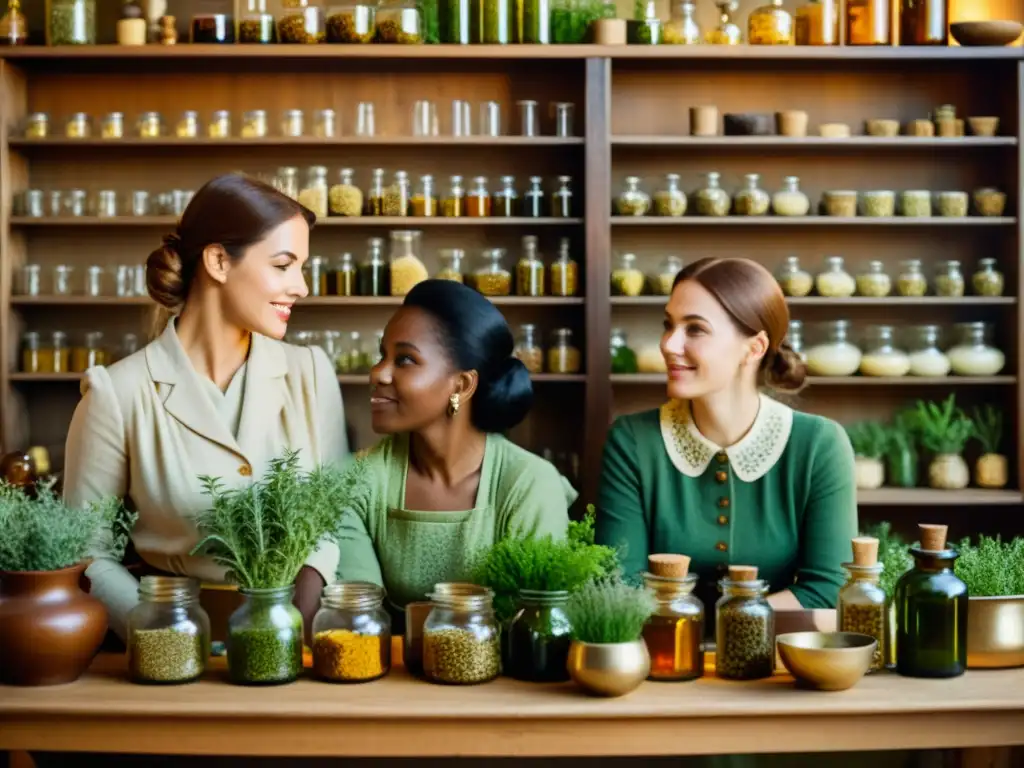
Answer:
[953,536,1024,669]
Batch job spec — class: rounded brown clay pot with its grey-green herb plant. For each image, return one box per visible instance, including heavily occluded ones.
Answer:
[0,480,135,685]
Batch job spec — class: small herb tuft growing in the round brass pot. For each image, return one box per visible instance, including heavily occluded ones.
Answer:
[565,580,655,643]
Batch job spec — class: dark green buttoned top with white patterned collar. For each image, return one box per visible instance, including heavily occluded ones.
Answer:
[597,395,857,624]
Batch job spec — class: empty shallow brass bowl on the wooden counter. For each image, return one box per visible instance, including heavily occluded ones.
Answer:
[776,632,878,690]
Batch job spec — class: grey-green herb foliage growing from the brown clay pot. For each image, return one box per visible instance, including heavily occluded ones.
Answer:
[0,480,137,570]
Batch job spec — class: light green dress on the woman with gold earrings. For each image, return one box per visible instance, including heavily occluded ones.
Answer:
[338,434,577,608]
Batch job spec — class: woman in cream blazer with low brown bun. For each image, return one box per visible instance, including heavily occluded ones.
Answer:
[65,174,348,637]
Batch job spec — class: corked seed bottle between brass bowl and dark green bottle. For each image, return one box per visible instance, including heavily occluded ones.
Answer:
[837,537,887,672]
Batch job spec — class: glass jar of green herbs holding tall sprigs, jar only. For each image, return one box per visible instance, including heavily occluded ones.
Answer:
[227,585,302,685]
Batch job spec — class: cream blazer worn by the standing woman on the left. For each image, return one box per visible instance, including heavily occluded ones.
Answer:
[63,322,348,637]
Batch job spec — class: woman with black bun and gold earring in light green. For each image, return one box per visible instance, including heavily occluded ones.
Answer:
[338,280,577,607]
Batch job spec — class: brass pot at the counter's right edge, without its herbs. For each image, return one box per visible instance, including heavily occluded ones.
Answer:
[967,595,1024,670]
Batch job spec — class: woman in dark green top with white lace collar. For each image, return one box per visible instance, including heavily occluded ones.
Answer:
[597,258,857,627]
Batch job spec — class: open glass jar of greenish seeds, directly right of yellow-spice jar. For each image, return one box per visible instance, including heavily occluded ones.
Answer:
[423,585,501,685]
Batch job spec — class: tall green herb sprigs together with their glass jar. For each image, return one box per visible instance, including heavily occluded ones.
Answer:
[193,452,365,685]
